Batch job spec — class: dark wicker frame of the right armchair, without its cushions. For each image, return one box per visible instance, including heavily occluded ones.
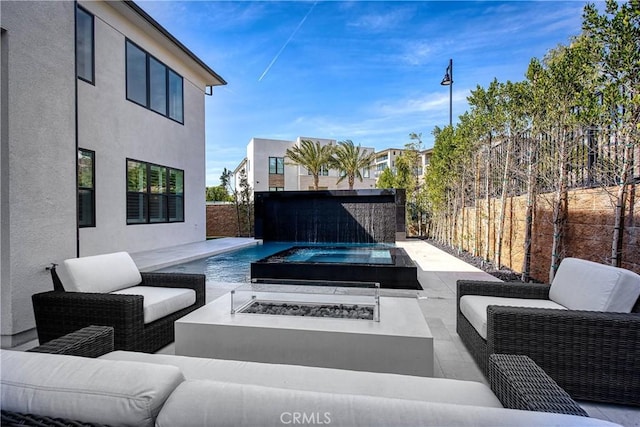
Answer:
[457,280,640,405]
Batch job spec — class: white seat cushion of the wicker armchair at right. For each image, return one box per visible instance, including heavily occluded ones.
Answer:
[460,295,566,340]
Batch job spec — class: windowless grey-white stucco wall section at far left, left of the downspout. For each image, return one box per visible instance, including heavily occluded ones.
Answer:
[0,1,77,347]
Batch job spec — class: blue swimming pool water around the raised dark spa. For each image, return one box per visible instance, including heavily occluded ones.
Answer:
[158,242,393,283]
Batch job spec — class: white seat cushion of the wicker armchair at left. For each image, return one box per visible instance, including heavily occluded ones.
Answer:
[111,286,196,324]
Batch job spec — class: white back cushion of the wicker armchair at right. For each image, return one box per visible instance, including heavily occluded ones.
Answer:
[549,258,640,313]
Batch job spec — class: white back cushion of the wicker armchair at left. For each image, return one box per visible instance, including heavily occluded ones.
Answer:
[56,252,142,293]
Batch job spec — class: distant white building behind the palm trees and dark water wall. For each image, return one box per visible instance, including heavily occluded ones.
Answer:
[239,137,376,191]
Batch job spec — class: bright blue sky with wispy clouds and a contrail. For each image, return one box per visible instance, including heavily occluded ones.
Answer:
[137,0,600,186]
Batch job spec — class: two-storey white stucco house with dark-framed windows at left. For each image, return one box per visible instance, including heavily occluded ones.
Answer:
[0,0,226,347]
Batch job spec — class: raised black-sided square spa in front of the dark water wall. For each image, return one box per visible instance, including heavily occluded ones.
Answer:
[251,245,422,289]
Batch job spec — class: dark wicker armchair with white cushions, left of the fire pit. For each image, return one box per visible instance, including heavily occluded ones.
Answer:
[32,252,205,352]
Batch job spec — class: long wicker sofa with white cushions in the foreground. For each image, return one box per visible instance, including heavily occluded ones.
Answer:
[1,326,615,427]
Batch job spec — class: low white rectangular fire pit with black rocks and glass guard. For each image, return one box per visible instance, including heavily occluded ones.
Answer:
[175,292,433,376]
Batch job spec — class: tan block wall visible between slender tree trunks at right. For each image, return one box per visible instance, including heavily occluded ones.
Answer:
[456,185,640,282]
